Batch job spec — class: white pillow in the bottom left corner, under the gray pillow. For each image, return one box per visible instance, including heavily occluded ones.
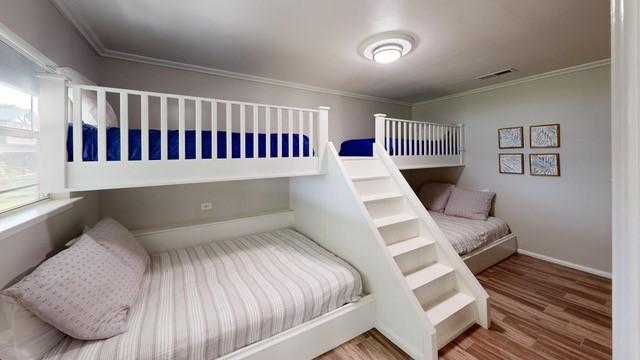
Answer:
[0,295,65,360]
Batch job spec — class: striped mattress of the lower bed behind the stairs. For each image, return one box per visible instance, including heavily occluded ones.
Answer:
[429,211,511,255]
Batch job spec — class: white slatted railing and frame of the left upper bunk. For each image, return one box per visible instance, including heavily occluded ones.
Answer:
[38,74,329,193]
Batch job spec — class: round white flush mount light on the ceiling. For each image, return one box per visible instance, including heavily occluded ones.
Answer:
[359,31,416,64]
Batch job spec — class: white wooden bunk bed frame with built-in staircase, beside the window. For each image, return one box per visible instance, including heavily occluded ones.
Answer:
[13,75,489,360]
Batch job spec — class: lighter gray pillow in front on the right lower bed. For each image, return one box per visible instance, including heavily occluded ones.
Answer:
[444,187,496,220]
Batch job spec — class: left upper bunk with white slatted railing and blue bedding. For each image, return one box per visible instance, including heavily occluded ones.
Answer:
[39,74,329,193]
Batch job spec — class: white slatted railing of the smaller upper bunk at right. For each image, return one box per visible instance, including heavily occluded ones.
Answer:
[374,114,464,170]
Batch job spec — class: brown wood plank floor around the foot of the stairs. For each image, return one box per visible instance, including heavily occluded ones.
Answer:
[319,255,611,360]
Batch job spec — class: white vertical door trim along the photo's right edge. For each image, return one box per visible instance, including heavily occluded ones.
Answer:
[611,0,640,360]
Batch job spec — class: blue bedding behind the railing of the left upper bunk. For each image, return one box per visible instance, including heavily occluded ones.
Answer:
[67,124,309,161]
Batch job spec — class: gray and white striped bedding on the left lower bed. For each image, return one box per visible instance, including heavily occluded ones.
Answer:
[44,229,362,360]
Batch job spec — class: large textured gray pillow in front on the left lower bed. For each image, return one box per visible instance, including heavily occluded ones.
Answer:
[2,235,142,340]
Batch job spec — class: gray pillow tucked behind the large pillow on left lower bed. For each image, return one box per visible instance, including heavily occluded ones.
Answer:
[87,218,150,273]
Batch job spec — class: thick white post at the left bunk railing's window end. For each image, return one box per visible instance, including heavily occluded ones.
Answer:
[38,74,69,193]
